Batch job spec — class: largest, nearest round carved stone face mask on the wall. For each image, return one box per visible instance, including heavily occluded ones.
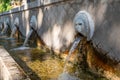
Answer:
[74,11,94,41]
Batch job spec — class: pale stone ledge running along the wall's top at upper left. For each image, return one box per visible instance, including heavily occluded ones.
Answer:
[0,0,72,16]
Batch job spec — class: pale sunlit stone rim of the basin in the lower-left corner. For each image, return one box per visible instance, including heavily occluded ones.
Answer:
[0,47,30,80]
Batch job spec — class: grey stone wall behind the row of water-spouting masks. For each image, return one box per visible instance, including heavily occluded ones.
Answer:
[0,0,120,60]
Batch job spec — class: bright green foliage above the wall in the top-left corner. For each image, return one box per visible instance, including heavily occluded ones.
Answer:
[0,0,11,13]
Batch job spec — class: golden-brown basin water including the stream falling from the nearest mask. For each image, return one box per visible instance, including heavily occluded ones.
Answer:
[0,34,115,80]
